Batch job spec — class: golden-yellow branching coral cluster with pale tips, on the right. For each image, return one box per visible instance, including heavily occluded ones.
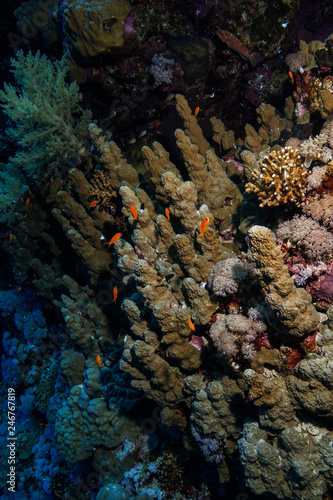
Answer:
[245,147,308,207]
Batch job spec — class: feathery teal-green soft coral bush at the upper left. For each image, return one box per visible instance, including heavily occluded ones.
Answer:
[0,50,91,178]
